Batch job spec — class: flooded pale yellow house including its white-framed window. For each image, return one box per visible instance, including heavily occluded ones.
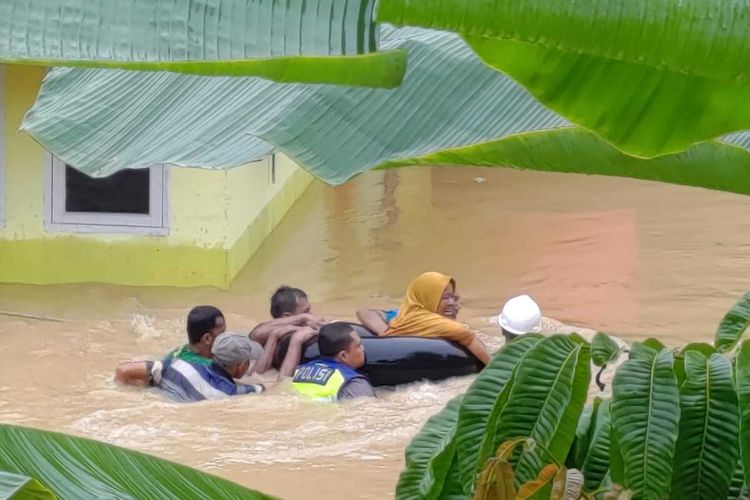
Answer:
[0,64,312,287]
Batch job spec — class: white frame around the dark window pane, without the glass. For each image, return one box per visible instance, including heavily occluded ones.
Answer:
[44,153,169,236]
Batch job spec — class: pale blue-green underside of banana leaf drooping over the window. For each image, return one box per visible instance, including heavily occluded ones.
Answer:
[23,27,567,183]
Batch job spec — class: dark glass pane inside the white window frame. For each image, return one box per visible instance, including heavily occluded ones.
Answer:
[65,165,150,215]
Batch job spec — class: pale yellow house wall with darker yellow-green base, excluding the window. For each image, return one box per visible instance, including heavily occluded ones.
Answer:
[0,66,311,287]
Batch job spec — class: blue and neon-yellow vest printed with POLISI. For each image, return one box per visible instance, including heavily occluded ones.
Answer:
[292,359,362,401]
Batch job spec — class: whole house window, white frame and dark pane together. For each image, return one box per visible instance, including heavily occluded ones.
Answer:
[45,154,169,235]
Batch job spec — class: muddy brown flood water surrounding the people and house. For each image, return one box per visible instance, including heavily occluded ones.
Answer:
[0,168,750,499]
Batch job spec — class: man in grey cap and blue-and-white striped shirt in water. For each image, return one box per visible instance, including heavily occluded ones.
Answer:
[151,333,265,401]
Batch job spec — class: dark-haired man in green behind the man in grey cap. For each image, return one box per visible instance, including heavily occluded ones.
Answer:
[115,306,227,385]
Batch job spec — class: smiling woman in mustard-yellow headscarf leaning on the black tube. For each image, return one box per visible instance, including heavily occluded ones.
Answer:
[383,272,490,364]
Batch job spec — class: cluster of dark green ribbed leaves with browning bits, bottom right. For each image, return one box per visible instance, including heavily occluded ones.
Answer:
[397,295,750,500]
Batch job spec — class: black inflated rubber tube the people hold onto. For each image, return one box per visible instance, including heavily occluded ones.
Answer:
[303,323,484,386]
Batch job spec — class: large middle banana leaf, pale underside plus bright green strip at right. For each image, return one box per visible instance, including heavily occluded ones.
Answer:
[22,26,750,194]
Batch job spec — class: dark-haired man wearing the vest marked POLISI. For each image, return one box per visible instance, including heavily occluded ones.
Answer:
[292,323,375,401]
